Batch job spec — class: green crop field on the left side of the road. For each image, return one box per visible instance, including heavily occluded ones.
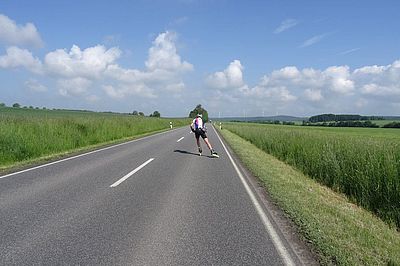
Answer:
[0,108,189,169]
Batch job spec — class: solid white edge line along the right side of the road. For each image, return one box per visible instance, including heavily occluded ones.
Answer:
[213,127,295,265]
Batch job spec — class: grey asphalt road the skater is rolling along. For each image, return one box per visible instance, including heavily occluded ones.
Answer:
[0,127,308,265]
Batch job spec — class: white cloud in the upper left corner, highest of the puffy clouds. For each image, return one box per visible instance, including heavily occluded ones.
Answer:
[0,14,43,47]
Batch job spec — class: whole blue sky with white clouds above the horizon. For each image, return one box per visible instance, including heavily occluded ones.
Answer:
[0,0,400,116]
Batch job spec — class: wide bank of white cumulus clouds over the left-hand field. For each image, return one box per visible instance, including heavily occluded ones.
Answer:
[0,31,192,101]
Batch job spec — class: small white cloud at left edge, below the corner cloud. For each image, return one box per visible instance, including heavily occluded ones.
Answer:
[0,46,43,74]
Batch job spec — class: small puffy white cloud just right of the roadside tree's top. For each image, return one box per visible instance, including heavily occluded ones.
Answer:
[206,60,244,89]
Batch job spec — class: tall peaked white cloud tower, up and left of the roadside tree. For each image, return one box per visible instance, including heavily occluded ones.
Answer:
[146,31,193,72]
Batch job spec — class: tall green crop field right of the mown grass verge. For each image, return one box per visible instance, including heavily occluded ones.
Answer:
[225,123,400,228]
